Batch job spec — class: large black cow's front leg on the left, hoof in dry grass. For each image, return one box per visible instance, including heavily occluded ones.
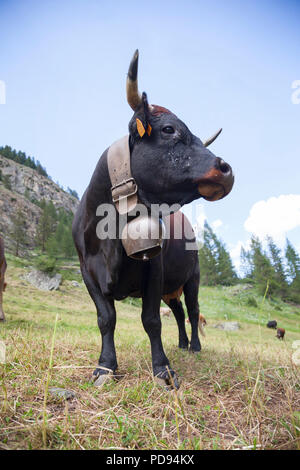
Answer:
[81,266,118,386]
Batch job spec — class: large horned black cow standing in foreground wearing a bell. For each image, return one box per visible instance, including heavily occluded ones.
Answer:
[73,51,234,387]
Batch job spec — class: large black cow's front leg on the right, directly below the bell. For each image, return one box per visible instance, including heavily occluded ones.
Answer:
[142,256,179,390]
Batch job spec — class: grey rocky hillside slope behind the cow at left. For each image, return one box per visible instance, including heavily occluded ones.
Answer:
[0,155,79,248]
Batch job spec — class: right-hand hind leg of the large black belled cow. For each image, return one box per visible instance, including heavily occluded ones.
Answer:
[183,269,201,352]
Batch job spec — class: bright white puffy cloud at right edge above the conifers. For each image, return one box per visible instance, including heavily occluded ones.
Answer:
[244,194,300,241]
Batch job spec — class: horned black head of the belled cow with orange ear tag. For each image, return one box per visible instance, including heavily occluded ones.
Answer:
[127,51,234,206]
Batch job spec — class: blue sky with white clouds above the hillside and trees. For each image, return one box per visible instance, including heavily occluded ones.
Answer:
[0,0,300,268]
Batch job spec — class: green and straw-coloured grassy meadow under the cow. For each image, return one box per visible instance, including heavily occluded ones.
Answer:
[0,256,300,450]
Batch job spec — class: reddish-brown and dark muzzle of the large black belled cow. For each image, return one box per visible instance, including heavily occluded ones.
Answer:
[197,157,234,201]
